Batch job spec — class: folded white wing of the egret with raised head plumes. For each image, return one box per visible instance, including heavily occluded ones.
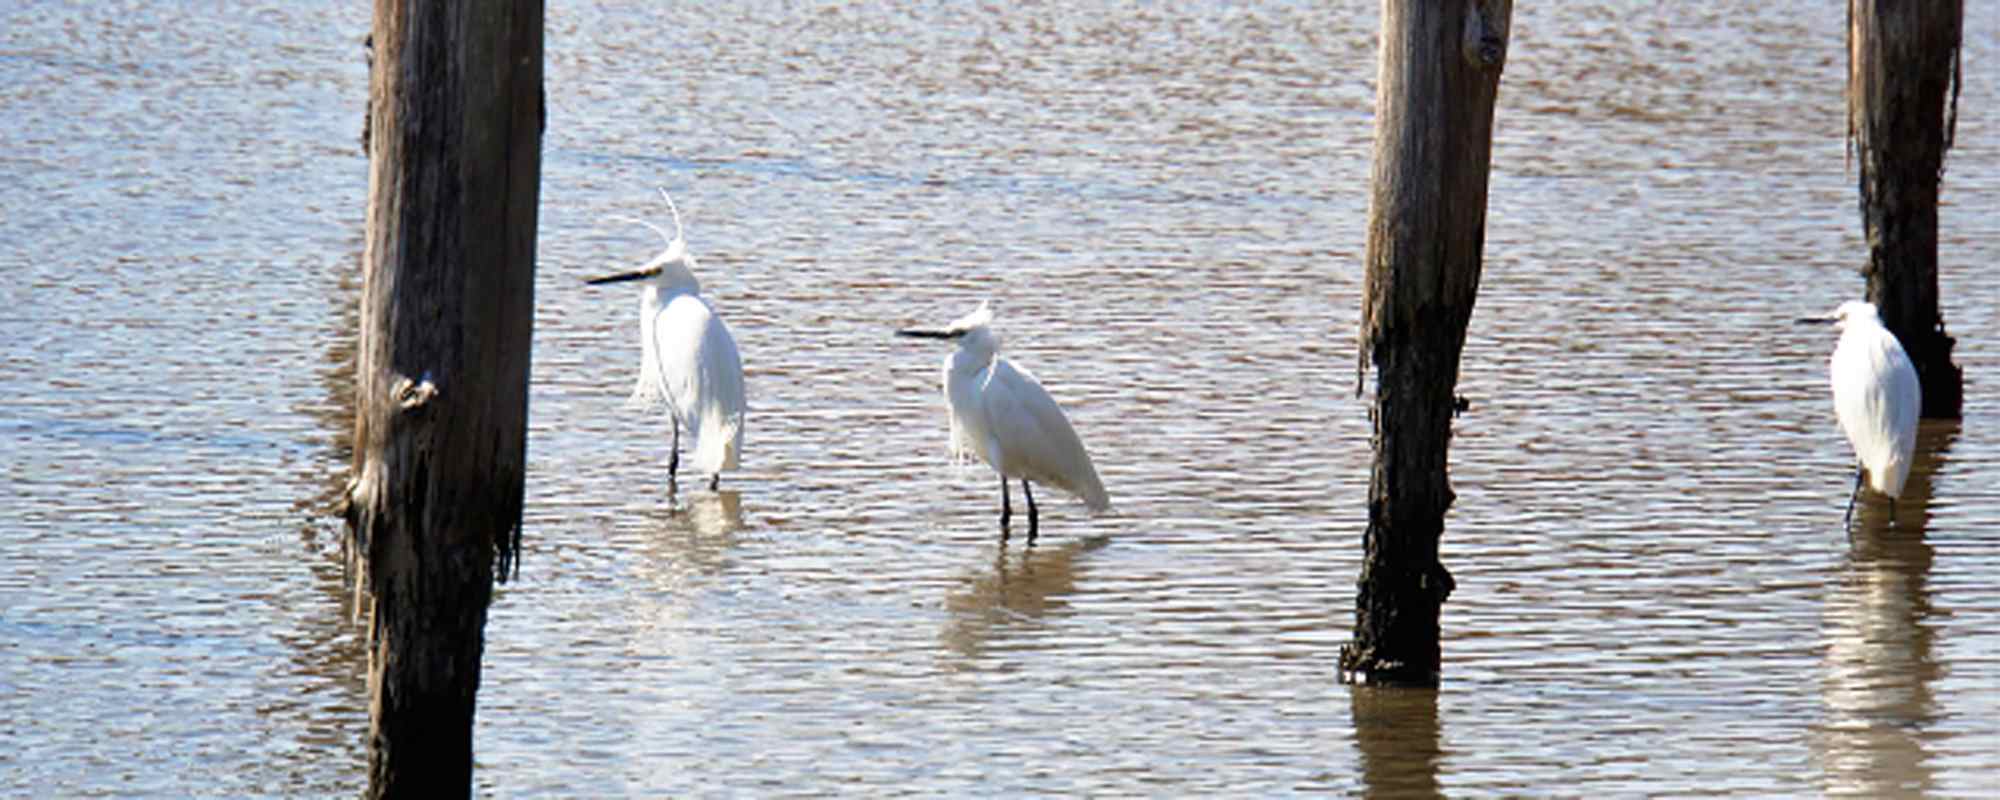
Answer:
[654,294,748,472]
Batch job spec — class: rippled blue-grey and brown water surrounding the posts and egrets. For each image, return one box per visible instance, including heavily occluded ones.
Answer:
[0,2,2000,796]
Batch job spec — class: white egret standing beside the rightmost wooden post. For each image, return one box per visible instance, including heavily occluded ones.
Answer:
[1798,300,1924,524]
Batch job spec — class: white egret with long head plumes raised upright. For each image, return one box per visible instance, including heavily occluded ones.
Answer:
[588,188,746,492]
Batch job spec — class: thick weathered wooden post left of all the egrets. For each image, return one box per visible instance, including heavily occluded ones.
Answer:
[346,0,542,798]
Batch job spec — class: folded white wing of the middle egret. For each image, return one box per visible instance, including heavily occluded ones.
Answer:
[980,358,1110,510]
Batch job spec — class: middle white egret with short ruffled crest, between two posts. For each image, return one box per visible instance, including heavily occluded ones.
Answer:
[896,302,1110,544]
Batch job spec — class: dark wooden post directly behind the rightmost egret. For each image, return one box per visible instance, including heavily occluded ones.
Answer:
[1848,0,1966,420]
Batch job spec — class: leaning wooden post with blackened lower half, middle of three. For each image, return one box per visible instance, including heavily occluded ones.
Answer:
[1340,0,1512,684]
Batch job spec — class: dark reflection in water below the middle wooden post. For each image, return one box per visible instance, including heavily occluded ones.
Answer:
[1350,686,1444,798]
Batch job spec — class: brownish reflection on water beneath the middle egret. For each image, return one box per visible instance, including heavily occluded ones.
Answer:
[942,536,1110,658]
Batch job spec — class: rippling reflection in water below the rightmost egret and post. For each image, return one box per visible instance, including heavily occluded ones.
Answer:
[1812,420,1958,796]
